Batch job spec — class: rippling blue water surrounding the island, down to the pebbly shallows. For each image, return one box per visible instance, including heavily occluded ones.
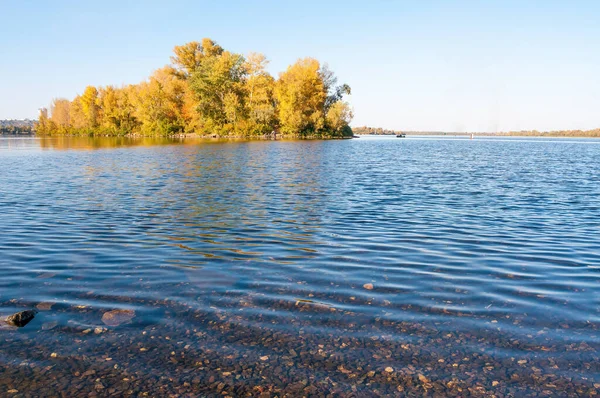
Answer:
[0,137,600,396]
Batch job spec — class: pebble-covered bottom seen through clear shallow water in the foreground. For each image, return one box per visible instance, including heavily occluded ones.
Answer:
[0,284,600,397]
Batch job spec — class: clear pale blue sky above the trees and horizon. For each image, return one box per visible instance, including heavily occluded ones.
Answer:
[0,0,600,131]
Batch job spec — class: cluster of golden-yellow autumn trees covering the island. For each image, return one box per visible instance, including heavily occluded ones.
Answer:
[37,39,352,138]
